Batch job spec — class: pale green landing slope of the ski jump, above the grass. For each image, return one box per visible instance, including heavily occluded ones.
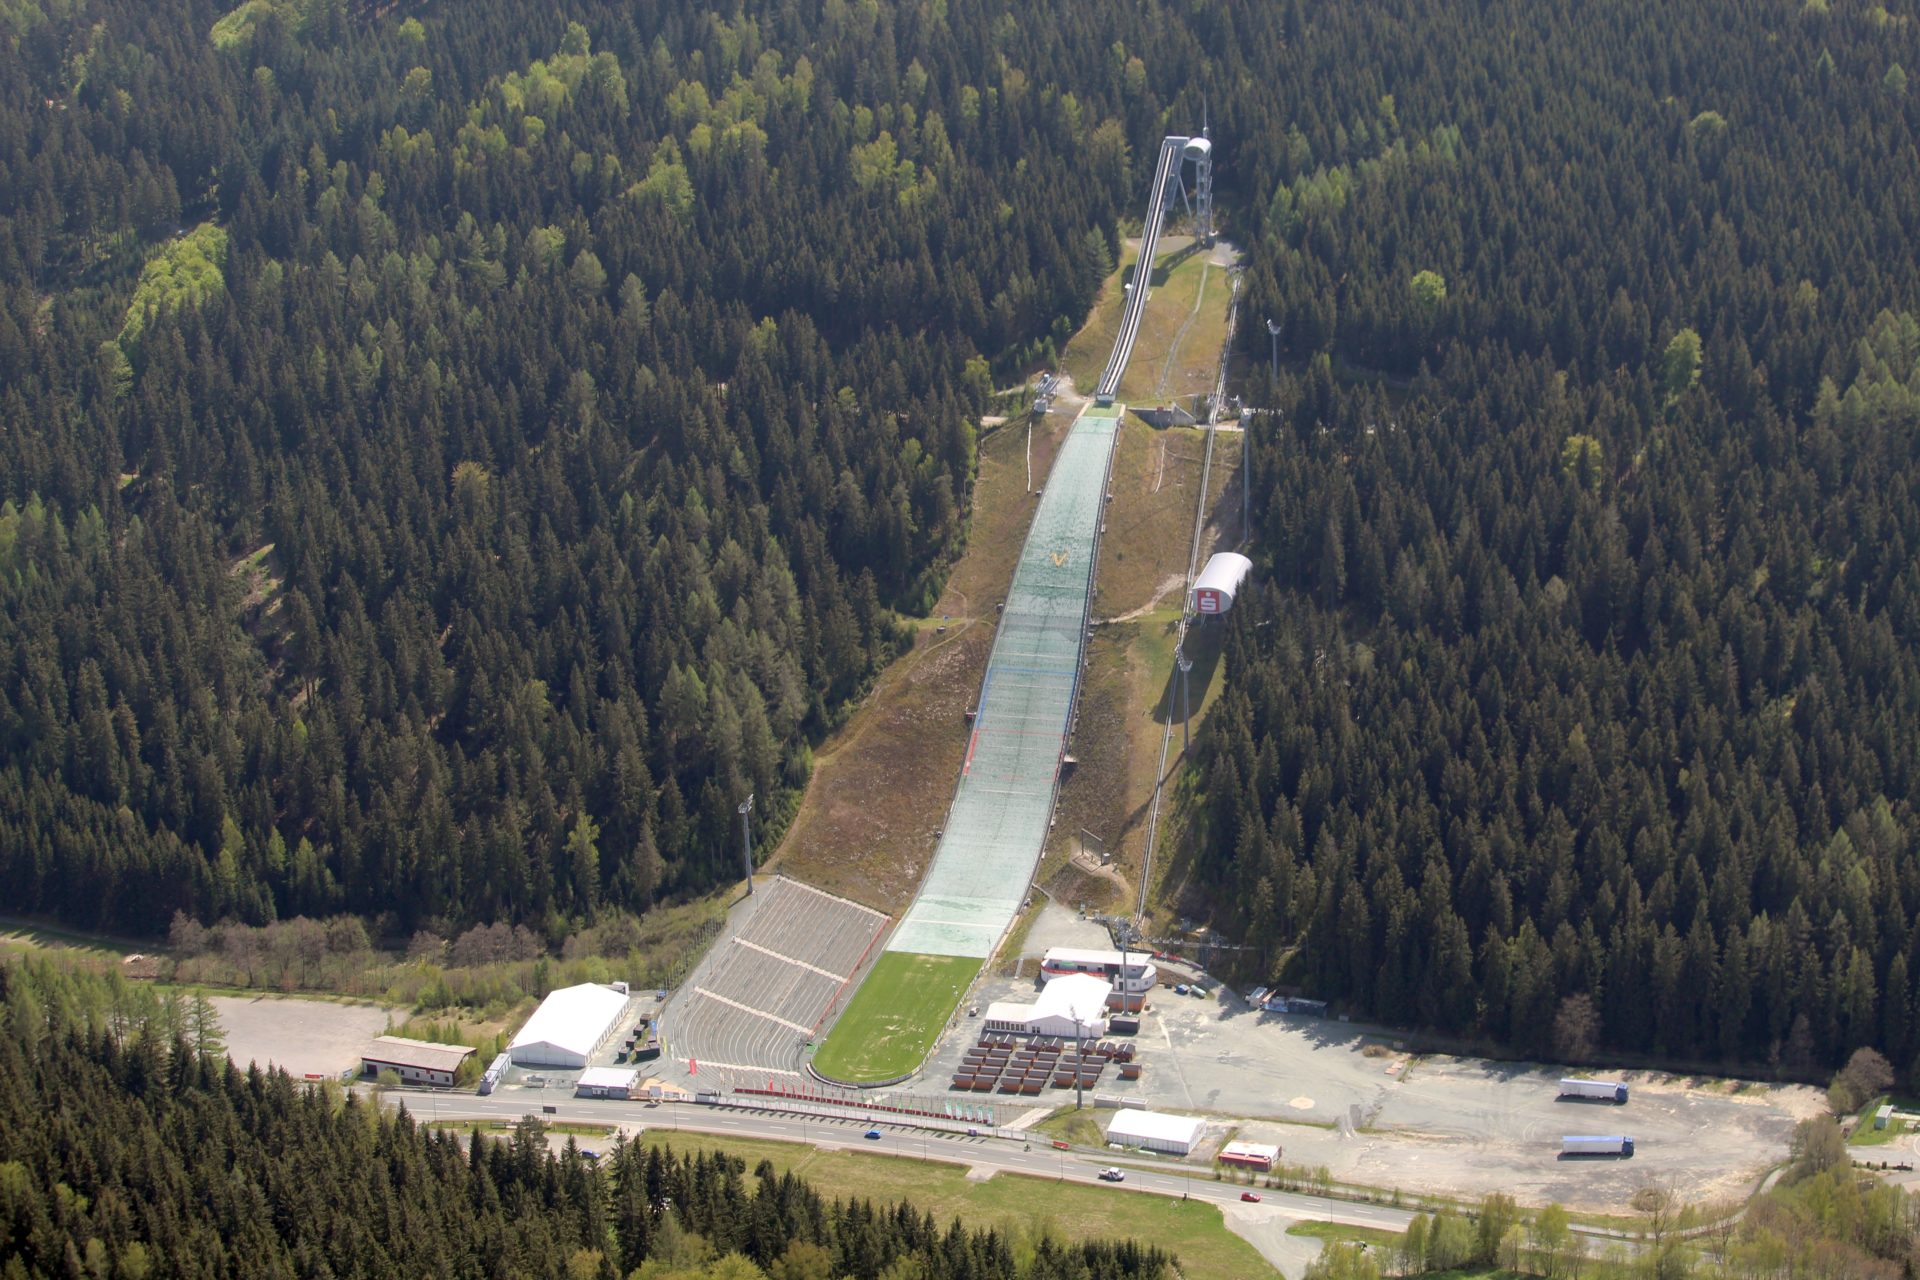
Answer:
[887,407,1119,960]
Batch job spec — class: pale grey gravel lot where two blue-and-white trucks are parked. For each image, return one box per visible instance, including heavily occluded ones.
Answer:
[924,910,1820,1213]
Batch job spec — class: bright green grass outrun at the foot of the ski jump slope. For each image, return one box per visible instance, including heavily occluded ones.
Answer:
[814,952,979,1084]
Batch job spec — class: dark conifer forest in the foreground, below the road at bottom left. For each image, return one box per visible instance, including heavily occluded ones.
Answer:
[0,961,1173,1280]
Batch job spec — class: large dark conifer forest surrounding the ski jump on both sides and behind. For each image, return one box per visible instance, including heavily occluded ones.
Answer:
[0,0,1920,1071]
